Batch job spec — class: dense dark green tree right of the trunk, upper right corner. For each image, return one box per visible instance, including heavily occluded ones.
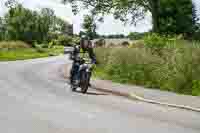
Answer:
[159,0,194,34]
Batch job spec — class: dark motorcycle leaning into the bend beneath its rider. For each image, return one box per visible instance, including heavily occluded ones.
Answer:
[71,59,92,94]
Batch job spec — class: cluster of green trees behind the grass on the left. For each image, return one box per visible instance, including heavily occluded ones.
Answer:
[0,0,69,43]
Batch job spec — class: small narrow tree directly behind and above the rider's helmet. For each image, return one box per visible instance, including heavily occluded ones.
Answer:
[82,15,97,39]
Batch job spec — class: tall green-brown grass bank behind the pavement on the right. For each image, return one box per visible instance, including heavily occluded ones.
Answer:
[95,40,200,95]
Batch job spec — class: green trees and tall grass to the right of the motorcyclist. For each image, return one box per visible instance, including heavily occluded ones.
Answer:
[63,0,200,95]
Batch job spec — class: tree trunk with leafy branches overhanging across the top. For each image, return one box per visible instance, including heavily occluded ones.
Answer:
[63,0,159,32]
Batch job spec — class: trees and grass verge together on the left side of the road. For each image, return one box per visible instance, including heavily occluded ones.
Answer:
[0,0,79,61]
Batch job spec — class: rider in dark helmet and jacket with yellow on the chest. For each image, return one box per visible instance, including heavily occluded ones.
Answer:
[70,37,96,86]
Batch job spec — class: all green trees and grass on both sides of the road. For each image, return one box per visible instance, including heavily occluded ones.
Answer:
[0,0,200,96]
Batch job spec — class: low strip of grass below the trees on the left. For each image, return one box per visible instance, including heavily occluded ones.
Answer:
[0,41,64,61]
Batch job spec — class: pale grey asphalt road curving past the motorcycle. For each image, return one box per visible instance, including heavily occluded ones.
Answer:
[0,56,200,133]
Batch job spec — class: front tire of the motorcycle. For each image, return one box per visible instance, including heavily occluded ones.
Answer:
[80,71,90,94]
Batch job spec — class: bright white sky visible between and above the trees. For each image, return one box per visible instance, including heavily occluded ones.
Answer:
[0,0,200,35]
